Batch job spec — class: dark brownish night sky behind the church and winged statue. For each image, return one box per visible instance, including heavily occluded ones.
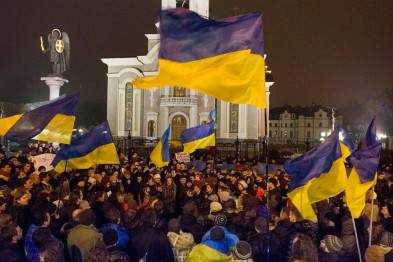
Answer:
[0,0,393,125]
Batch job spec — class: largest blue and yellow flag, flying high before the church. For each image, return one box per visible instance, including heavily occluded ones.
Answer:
[134,8,266,108]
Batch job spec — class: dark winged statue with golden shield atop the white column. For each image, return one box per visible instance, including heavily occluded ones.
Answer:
[40,28,70,77]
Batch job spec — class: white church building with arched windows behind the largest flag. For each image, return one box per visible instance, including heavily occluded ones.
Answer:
[102,0,274,140]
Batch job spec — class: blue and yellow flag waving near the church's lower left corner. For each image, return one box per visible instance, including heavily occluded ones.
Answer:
[52,122,119,173]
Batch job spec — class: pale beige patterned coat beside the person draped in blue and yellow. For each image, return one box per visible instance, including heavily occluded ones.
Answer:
[167,231,195,262]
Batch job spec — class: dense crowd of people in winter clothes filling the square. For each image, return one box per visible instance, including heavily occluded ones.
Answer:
[0,142,393,262]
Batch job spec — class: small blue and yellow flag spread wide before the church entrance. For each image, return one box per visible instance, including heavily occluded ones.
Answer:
[180,122,216,154]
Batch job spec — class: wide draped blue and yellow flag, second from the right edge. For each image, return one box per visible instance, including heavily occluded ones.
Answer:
[284,130,350,221]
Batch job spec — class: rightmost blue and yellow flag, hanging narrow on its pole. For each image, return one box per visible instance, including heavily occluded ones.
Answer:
[345,119,381,218]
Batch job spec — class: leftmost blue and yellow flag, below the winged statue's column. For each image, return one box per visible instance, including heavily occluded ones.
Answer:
[0,94,79,144]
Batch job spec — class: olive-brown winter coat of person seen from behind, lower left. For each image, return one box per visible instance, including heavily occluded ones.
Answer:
[67,225,102,260]
